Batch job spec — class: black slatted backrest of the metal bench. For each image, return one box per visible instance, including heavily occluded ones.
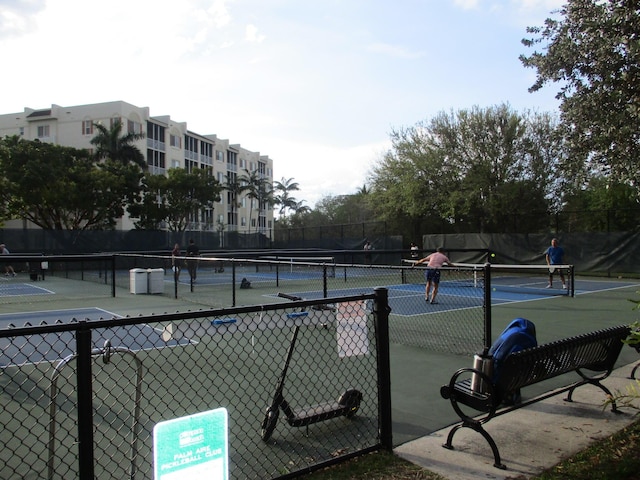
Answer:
[496,325,630,392]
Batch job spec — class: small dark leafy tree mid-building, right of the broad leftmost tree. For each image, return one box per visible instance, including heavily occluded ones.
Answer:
[129,168,222,232]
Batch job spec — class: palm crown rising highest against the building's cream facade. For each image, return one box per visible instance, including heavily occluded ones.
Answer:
[91,118,147,170]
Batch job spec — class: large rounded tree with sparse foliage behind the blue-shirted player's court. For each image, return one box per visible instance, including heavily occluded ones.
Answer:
[370,104,563,234]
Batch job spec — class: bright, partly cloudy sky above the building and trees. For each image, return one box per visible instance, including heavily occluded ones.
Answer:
[0,0,565,208]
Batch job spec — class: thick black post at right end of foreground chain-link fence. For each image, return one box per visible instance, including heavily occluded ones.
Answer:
[373,287,393,451]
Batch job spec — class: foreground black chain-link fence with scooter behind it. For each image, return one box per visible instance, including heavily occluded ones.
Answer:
[0,289,391,479]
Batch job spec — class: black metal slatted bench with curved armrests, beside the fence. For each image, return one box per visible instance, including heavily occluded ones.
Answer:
[440,325,630,469]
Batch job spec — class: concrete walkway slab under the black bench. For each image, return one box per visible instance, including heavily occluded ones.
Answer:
[395,364,640,480]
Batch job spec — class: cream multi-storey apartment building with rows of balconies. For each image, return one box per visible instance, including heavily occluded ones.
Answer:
[0,101,273,237]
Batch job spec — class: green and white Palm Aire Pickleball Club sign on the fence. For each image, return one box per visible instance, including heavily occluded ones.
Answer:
[153,408,229,480]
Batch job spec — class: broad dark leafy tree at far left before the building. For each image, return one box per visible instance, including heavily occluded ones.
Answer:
[0,137,141,243]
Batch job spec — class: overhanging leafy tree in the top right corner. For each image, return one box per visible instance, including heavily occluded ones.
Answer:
[520,0,640,187]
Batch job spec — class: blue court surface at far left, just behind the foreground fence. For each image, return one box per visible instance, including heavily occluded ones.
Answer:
[0,308,192,367]
